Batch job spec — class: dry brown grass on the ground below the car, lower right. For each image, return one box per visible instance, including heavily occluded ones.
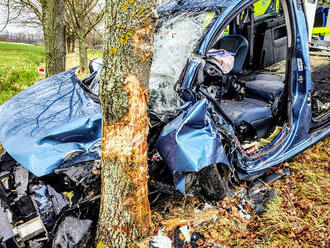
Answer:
[148,137,330,248]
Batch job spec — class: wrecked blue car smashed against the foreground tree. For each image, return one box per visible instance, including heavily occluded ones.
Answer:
[0,0,330,247]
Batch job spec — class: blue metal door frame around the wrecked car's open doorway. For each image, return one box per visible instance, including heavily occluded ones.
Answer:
[156,0,330,188]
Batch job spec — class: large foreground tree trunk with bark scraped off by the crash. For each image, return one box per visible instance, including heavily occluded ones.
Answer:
[97,0,155,247]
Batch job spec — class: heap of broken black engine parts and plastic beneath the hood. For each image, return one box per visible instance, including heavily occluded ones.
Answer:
[0,153,100,248]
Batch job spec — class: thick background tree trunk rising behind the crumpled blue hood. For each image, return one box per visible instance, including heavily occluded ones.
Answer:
[40,0,66,76]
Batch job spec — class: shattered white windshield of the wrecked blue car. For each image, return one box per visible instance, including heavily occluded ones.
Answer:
[149,10,216,113]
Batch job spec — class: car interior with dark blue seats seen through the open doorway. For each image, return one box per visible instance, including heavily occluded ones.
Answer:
[200,0,288,145]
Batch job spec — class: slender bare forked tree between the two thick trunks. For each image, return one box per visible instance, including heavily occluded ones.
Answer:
[65,0,104,72]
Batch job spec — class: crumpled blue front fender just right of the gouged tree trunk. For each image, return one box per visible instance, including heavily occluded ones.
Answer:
[156,99,229,193]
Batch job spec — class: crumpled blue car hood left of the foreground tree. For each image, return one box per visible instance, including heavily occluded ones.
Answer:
[0,68,102,176]
